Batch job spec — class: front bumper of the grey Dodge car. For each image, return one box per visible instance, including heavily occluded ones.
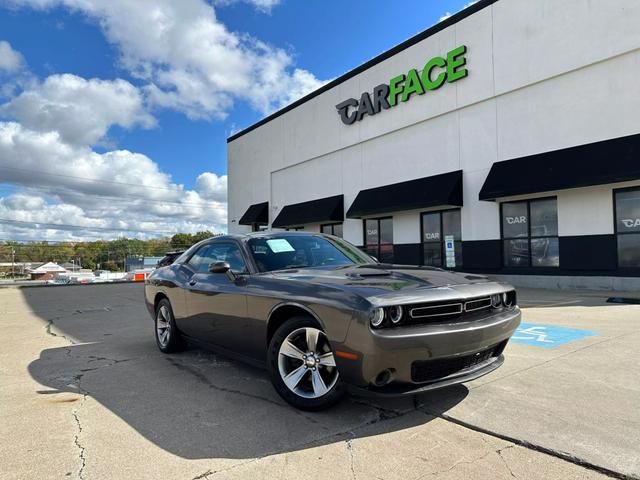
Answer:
[335,307,521,395]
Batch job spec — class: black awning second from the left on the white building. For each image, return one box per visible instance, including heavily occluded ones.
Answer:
[271,195,344,228]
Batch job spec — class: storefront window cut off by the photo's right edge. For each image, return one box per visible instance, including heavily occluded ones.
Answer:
[615,188,640,268]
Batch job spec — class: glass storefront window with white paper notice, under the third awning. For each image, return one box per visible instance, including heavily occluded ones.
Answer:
[422,210,462,268]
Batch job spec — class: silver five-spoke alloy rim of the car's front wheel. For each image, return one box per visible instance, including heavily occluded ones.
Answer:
[278,327,338,398]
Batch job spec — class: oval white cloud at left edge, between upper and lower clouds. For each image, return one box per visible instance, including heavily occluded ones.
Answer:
[0,74,155,145]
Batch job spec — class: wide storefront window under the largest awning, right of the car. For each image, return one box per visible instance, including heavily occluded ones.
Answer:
[501,198,560,267]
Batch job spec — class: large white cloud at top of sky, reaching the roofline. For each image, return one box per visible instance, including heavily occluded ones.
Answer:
[10,0,323,118]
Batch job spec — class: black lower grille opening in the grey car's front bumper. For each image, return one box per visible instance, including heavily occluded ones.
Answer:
[411,340,507,383]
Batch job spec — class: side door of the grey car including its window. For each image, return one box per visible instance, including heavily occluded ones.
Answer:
[185,241,247,352]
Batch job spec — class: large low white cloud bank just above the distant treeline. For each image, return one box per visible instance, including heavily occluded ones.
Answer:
[0,122,227,239]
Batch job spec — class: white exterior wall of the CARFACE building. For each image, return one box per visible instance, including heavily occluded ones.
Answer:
[228,0,640,244]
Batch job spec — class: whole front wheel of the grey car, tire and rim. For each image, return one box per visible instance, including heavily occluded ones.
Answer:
[268,316,344,410]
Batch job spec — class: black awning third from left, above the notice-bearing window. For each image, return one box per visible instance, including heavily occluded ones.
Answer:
[347,170,462,218]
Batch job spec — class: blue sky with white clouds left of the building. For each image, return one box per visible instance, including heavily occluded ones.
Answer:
[0,0,473,242]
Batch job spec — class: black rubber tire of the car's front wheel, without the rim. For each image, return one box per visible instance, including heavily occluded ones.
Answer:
[267,316,344,411]
